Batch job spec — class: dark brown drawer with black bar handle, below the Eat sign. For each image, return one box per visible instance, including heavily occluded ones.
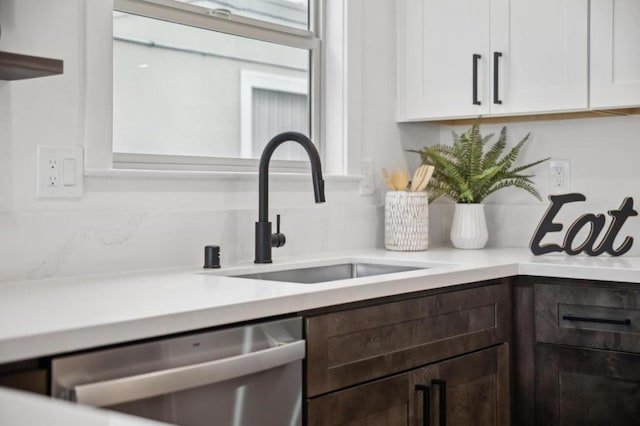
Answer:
[534,284,640,352]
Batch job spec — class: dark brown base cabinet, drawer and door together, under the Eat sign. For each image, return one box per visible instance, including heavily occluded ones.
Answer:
[519,279,640,426]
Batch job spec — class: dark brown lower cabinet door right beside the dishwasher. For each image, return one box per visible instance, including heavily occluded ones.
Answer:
[306,374,410,426]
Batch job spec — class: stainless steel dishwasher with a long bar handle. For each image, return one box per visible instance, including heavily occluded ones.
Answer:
[51,317,305,426]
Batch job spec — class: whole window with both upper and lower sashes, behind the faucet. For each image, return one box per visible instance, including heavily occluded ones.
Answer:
[113,0,323,170]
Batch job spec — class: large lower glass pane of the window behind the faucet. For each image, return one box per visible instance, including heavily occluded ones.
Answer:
[113,12,310,158]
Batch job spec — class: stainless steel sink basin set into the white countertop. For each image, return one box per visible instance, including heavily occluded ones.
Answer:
[236,263,426,284]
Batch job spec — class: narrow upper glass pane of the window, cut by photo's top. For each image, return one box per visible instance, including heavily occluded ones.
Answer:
[177,0,309,30]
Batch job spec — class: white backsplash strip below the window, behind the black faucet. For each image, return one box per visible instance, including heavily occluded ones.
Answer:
[0,205,381,282]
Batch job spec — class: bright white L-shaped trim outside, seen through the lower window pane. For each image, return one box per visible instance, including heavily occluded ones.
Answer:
[240,70,309,158]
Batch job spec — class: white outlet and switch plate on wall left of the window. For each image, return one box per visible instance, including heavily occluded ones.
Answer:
[36,145,83,198]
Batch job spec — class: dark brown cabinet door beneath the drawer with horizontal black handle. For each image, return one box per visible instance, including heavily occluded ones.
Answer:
[535,343,640,426]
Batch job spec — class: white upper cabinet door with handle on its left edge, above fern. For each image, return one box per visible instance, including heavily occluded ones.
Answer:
[491,0,592,115]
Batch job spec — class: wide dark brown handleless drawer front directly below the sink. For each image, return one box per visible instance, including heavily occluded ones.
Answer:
[306,284,510,397]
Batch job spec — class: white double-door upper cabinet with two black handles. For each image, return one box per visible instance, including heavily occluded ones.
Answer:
[397,0,588,121]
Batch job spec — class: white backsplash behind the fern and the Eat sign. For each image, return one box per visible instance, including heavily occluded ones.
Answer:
[432,115,640,257]
